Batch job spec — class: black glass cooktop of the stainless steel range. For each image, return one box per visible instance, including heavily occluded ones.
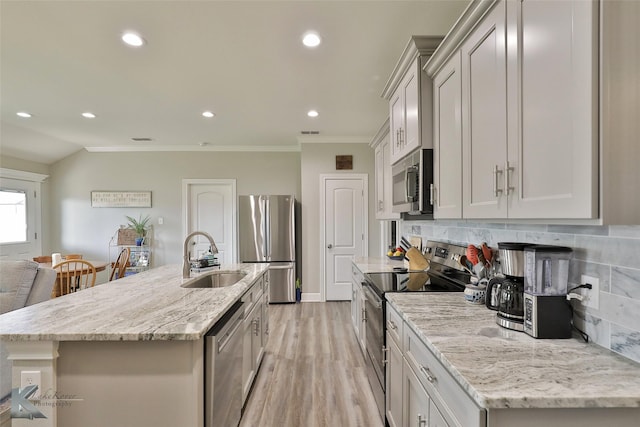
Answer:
[365,269,469,296]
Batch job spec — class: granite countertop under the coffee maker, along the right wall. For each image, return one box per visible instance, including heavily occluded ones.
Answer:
[386,293,640,409]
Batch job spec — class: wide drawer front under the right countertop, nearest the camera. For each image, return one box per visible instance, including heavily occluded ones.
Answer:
[403,326,486,427]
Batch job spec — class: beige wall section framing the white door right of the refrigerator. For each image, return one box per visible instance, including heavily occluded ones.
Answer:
[301,144,380,295]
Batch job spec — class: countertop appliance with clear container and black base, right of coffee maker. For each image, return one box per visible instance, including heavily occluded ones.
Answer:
[524,245,573,338]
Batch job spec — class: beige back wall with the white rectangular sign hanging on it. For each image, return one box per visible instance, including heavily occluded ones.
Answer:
[43,150,301,276]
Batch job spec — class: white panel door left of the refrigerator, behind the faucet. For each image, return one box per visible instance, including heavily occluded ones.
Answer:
[183,179,237,264]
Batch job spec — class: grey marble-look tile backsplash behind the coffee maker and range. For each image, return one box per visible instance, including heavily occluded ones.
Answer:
[401,220,640,362]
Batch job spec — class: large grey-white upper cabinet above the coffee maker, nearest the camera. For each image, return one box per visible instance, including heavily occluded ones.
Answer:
[425,0,608,219]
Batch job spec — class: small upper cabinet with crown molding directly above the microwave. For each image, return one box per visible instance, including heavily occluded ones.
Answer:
[382,36,442,164]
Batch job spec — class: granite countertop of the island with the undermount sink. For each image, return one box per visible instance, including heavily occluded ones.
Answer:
[0,264,268,341]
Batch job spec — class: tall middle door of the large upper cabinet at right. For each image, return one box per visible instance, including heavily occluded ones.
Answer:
[461,1,507,218]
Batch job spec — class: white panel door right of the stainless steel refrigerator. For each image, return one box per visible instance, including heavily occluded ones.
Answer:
[320,175,368,301]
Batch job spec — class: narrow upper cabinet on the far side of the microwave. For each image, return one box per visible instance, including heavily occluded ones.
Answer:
[370,120,400,220]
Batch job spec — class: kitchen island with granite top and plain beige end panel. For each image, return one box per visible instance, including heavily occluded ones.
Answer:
[0,264,268,427]
